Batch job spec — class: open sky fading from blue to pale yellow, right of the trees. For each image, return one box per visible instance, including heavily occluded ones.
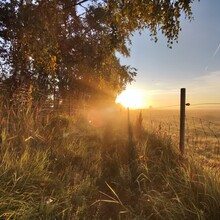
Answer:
[119,0,220,108]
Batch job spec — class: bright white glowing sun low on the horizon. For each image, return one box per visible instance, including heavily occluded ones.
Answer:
[115,89,146,109]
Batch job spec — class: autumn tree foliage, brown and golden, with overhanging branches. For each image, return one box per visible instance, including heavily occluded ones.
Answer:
[0,0,198,108]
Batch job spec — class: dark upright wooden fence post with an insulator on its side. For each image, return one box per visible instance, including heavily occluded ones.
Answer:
[180,88,186,156]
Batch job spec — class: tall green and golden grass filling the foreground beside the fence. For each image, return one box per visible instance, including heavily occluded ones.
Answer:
[0,104,220,220]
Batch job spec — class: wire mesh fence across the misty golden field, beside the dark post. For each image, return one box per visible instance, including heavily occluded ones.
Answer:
[144,103,220,174]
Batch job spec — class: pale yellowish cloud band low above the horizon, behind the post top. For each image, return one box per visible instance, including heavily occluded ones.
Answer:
[144,71,220,106]
